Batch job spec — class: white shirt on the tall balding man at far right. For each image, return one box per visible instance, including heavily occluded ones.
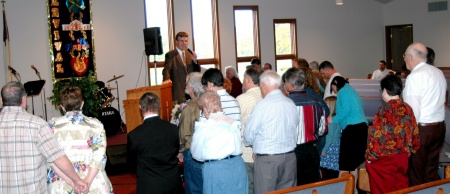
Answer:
[403,62,447,123]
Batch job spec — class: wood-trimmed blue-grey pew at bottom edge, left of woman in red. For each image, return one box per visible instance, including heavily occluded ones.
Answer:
[267,173,355,194]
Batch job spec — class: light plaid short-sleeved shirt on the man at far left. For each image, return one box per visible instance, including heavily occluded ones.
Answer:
[0,106,64,193]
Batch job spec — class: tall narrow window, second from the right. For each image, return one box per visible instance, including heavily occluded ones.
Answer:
[233,6,261,80]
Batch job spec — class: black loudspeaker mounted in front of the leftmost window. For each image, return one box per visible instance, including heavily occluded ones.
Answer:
[144,27,163,56]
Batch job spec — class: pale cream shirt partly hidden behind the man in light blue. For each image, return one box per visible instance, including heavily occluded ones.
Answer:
[236,87,262,162]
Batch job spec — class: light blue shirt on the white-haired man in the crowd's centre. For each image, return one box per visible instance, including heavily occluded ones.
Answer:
[244,89,299,154]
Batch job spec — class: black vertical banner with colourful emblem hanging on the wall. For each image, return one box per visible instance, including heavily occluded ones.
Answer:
[47,0,97,81]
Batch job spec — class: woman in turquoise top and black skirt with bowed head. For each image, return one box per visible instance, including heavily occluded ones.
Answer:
[328,76,367,183]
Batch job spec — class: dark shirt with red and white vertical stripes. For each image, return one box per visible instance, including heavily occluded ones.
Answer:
[288,90,326,144]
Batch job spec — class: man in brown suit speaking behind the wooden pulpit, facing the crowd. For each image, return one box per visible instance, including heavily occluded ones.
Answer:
[163,32,200,103]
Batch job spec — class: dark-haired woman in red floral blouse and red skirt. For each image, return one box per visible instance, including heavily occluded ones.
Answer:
[366,75,420,194]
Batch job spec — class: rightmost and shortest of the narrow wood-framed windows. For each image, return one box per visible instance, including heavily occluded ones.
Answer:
[273,19,297,75]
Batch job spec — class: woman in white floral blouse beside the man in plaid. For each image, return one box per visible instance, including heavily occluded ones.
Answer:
[47,86,113,193]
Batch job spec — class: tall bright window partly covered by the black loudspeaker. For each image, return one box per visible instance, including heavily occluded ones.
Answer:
[144,0,175,85]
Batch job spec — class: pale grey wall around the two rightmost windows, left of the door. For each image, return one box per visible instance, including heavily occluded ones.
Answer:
[219,0,384,78]
